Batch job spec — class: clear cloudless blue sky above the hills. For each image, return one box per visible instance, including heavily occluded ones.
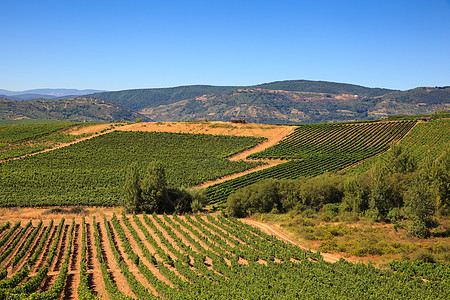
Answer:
[0,0,450,91]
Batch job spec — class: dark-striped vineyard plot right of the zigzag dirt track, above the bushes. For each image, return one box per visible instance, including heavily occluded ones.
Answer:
[206,121,416,205]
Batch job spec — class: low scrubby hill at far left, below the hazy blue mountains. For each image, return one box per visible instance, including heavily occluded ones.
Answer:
[0,98,150,122]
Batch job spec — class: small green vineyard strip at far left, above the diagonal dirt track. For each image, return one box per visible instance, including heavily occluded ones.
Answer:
[0,123,86,160]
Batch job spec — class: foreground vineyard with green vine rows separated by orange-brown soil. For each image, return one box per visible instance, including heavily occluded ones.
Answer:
[0,214,450,299]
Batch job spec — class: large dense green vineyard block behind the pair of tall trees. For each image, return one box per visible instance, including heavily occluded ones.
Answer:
[0,131,262,206]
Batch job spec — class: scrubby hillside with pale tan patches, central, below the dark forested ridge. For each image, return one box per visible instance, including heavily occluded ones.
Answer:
[140,88,384,123]
